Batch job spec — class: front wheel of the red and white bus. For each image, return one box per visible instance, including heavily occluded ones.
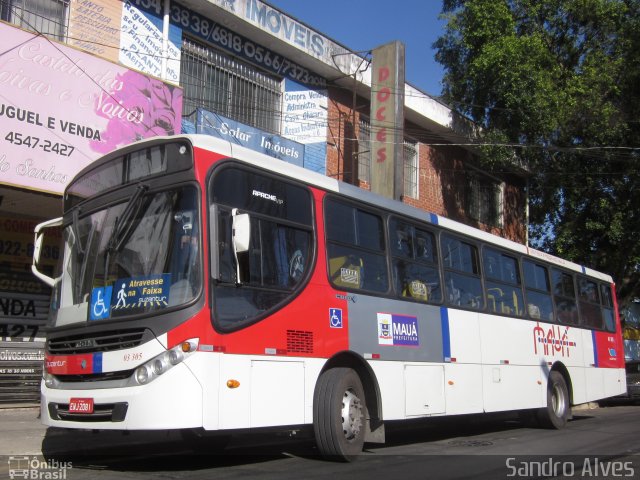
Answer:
[313,368,367,462]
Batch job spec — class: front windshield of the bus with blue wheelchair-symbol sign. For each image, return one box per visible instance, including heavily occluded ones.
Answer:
[50,186,201,326]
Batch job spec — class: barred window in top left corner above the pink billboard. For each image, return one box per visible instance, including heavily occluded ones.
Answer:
[0,0,69,41]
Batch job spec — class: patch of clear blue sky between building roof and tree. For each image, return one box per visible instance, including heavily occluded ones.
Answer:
[267,0,445,96]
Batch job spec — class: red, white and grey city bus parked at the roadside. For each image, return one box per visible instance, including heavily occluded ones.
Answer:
[34,135,625,460]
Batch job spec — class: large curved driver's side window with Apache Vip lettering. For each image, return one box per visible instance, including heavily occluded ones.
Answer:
[209,167,313,331]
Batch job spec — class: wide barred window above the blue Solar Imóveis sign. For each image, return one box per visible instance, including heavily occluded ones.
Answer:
[180,39,282,133]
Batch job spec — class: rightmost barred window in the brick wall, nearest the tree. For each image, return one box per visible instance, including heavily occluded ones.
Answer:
[466,172,503,227]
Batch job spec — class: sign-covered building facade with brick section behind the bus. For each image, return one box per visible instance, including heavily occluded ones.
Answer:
[0,0,526,405]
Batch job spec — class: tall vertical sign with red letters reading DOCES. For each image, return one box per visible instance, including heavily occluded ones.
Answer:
[371,41,404,199]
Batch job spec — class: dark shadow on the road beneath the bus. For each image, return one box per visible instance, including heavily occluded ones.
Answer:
[42,413,588,472]
